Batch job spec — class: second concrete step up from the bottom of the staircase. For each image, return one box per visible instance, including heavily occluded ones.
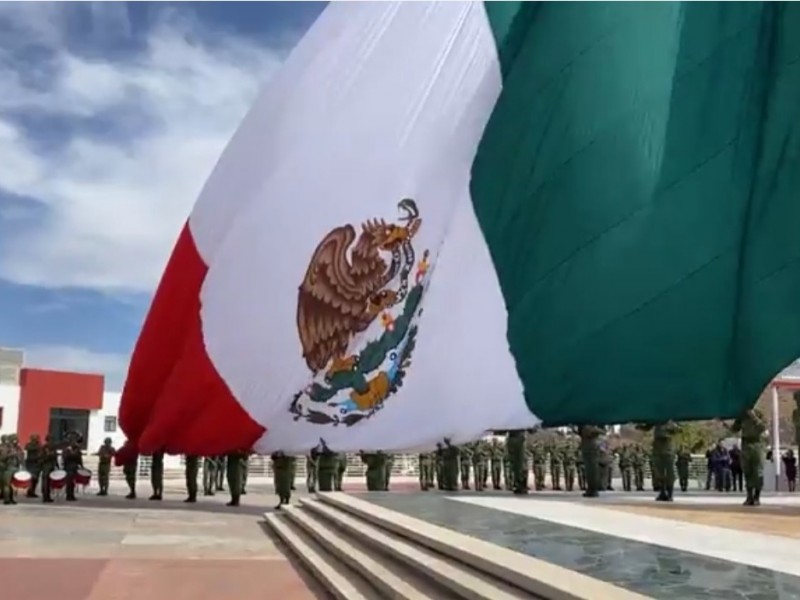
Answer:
[286,504,460,600]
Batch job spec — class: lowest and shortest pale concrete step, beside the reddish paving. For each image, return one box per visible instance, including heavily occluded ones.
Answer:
[264,513,381,600]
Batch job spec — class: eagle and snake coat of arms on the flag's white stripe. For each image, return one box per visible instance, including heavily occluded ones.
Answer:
[290,198,430,426]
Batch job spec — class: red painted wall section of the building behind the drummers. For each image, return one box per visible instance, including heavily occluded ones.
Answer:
[17,369,105,440]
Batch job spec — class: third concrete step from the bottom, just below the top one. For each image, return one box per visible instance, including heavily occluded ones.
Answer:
[301,499,531,600]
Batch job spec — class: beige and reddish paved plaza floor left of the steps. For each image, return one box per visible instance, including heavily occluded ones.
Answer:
[0,486,326,600]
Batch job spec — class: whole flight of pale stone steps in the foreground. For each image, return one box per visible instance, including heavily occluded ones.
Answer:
[264,493,645,600]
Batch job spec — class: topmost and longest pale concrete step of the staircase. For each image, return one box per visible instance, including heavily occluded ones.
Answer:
[316,492,647,600]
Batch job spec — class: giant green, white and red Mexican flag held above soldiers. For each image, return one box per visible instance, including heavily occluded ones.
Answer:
[115,2,800,454]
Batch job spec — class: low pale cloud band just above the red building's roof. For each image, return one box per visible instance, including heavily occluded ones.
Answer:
[25,346,129,390]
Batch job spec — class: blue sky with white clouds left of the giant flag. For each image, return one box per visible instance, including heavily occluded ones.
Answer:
[0,2,324,389]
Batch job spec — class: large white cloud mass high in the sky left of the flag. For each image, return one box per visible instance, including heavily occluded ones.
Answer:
[0,3,294,292]
